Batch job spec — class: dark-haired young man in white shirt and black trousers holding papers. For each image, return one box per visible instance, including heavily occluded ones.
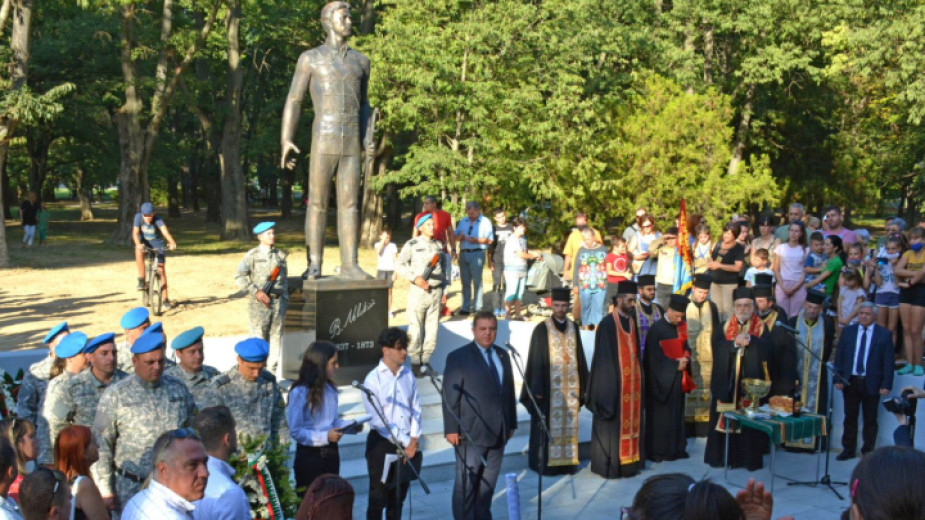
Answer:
[363,327,421,520]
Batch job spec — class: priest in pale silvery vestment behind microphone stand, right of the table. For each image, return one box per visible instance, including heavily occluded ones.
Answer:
[787,290,835,450]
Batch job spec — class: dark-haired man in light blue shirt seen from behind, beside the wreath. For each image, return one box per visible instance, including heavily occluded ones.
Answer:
[193,406,251,520]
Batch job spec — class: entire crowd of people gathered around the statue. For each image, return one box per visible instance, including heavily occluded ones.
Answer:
[0,198,925,520]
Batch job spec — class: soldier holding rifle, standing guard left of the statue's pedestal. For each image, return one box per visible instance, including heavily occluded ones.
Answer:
[234,222,289,375]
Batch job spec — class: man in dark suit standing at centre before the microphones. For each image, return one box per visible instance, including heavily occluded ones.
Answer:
[443,312,517,520]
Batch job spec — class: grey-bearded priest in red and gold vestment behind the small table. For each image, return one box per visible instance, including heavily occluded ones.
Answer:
[703,287,775,471]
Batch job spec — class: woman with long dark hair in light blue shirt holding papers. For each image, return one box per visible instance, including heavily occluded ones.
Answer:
[287,341,344,494]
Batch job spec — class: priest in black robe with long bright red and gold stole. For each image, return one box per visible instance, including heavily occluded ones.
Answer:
[587,281,645,478]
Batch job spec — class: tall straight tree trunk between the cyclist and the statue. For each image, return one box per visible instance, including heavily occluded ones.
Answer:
[219,0,245,240]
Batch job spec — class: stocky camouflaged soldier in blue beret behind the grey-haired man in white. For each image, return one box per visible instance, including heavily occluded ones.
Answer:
[93,334,196,509]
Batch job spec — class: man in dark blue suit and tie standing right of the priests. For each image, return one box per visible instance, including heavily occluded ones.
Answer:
[835,302,893,460]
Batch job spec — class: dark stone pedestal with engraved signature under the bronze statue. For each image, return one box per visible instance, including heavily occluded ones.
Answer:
[281,277,389,385]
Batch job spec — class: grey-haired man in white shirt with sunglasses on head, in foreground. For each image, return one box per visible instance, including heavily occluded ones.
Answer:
[121,428,209,520]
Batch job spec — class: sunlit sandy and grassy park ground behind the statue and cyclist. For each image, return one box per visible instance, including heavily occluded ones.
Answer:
[0,202,506,350]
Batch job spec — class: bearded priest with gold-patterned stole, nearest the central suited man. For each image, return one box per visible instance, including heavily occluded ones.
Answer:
[520,288,588,475]
